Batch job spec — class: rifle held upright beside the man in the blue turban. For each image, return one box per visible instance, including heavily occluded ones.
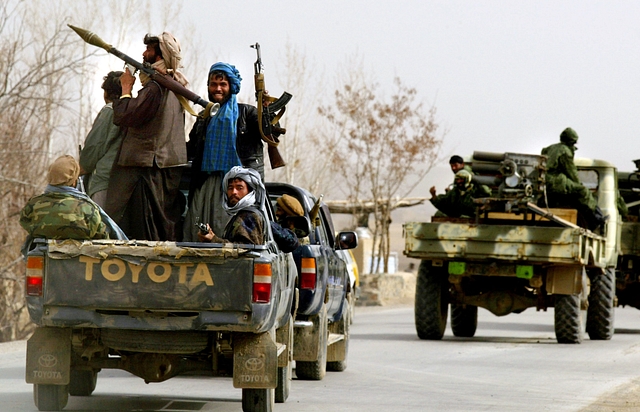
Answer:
[251,43,292,169]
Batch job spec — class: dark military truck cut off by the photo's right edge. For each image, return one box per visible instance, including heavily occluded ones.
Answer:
[616,160,640,309]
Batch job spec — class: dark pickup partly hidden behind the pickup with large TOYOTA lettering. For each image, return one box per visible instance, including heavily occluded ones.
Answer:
[265,183,358,380]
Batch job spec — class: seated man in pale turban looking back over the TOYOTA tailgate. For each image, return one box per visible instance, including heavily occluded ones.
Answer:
[198,166,298,253]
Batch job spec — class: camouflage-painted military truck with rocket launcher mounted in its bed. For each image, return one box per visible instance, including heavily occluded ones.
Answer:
[404,152,620,343]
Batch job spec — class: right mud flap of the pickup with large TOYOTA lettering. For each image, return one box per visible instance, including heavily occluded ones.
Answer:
[233,332,278,389]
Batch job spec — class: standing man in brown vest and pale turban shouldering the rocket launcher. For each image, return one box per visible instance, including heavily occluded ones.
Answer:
[105,32,188,240]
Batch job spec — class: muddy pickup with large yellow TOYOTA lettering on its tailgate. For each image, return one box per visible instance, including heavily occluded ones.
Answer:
[26,201,298,412]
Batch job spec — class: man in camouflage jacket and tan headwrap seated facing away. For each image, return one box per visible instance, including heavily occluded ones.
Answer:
[20,155,126,248]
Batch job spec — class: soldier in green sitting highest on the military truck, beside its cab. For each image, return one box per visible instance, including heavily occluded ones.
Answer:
[542,127,606,230]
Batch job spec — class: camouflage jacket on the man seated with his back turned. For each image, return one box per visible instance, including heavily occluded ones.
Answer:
[20,192,109,240]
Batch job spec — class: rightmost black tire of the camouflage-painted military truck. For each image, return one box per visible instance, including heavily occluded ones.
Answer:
[587,269,616,340]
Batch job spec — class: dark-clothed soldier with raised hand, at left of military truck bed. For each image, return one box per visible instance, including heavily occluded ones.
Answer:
[429,169,491,217]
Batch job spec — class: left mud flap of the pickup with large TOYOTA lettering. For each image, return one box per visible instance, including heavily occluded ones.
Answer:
[25,328,71,385]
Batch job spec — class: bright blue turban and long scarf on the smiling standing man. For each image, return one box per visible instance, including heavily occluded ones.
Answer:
[201,62,242,173]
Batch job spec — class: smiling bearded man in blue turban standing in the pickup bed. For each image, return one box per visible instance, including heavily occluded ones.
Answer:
[183,62,264,242]
